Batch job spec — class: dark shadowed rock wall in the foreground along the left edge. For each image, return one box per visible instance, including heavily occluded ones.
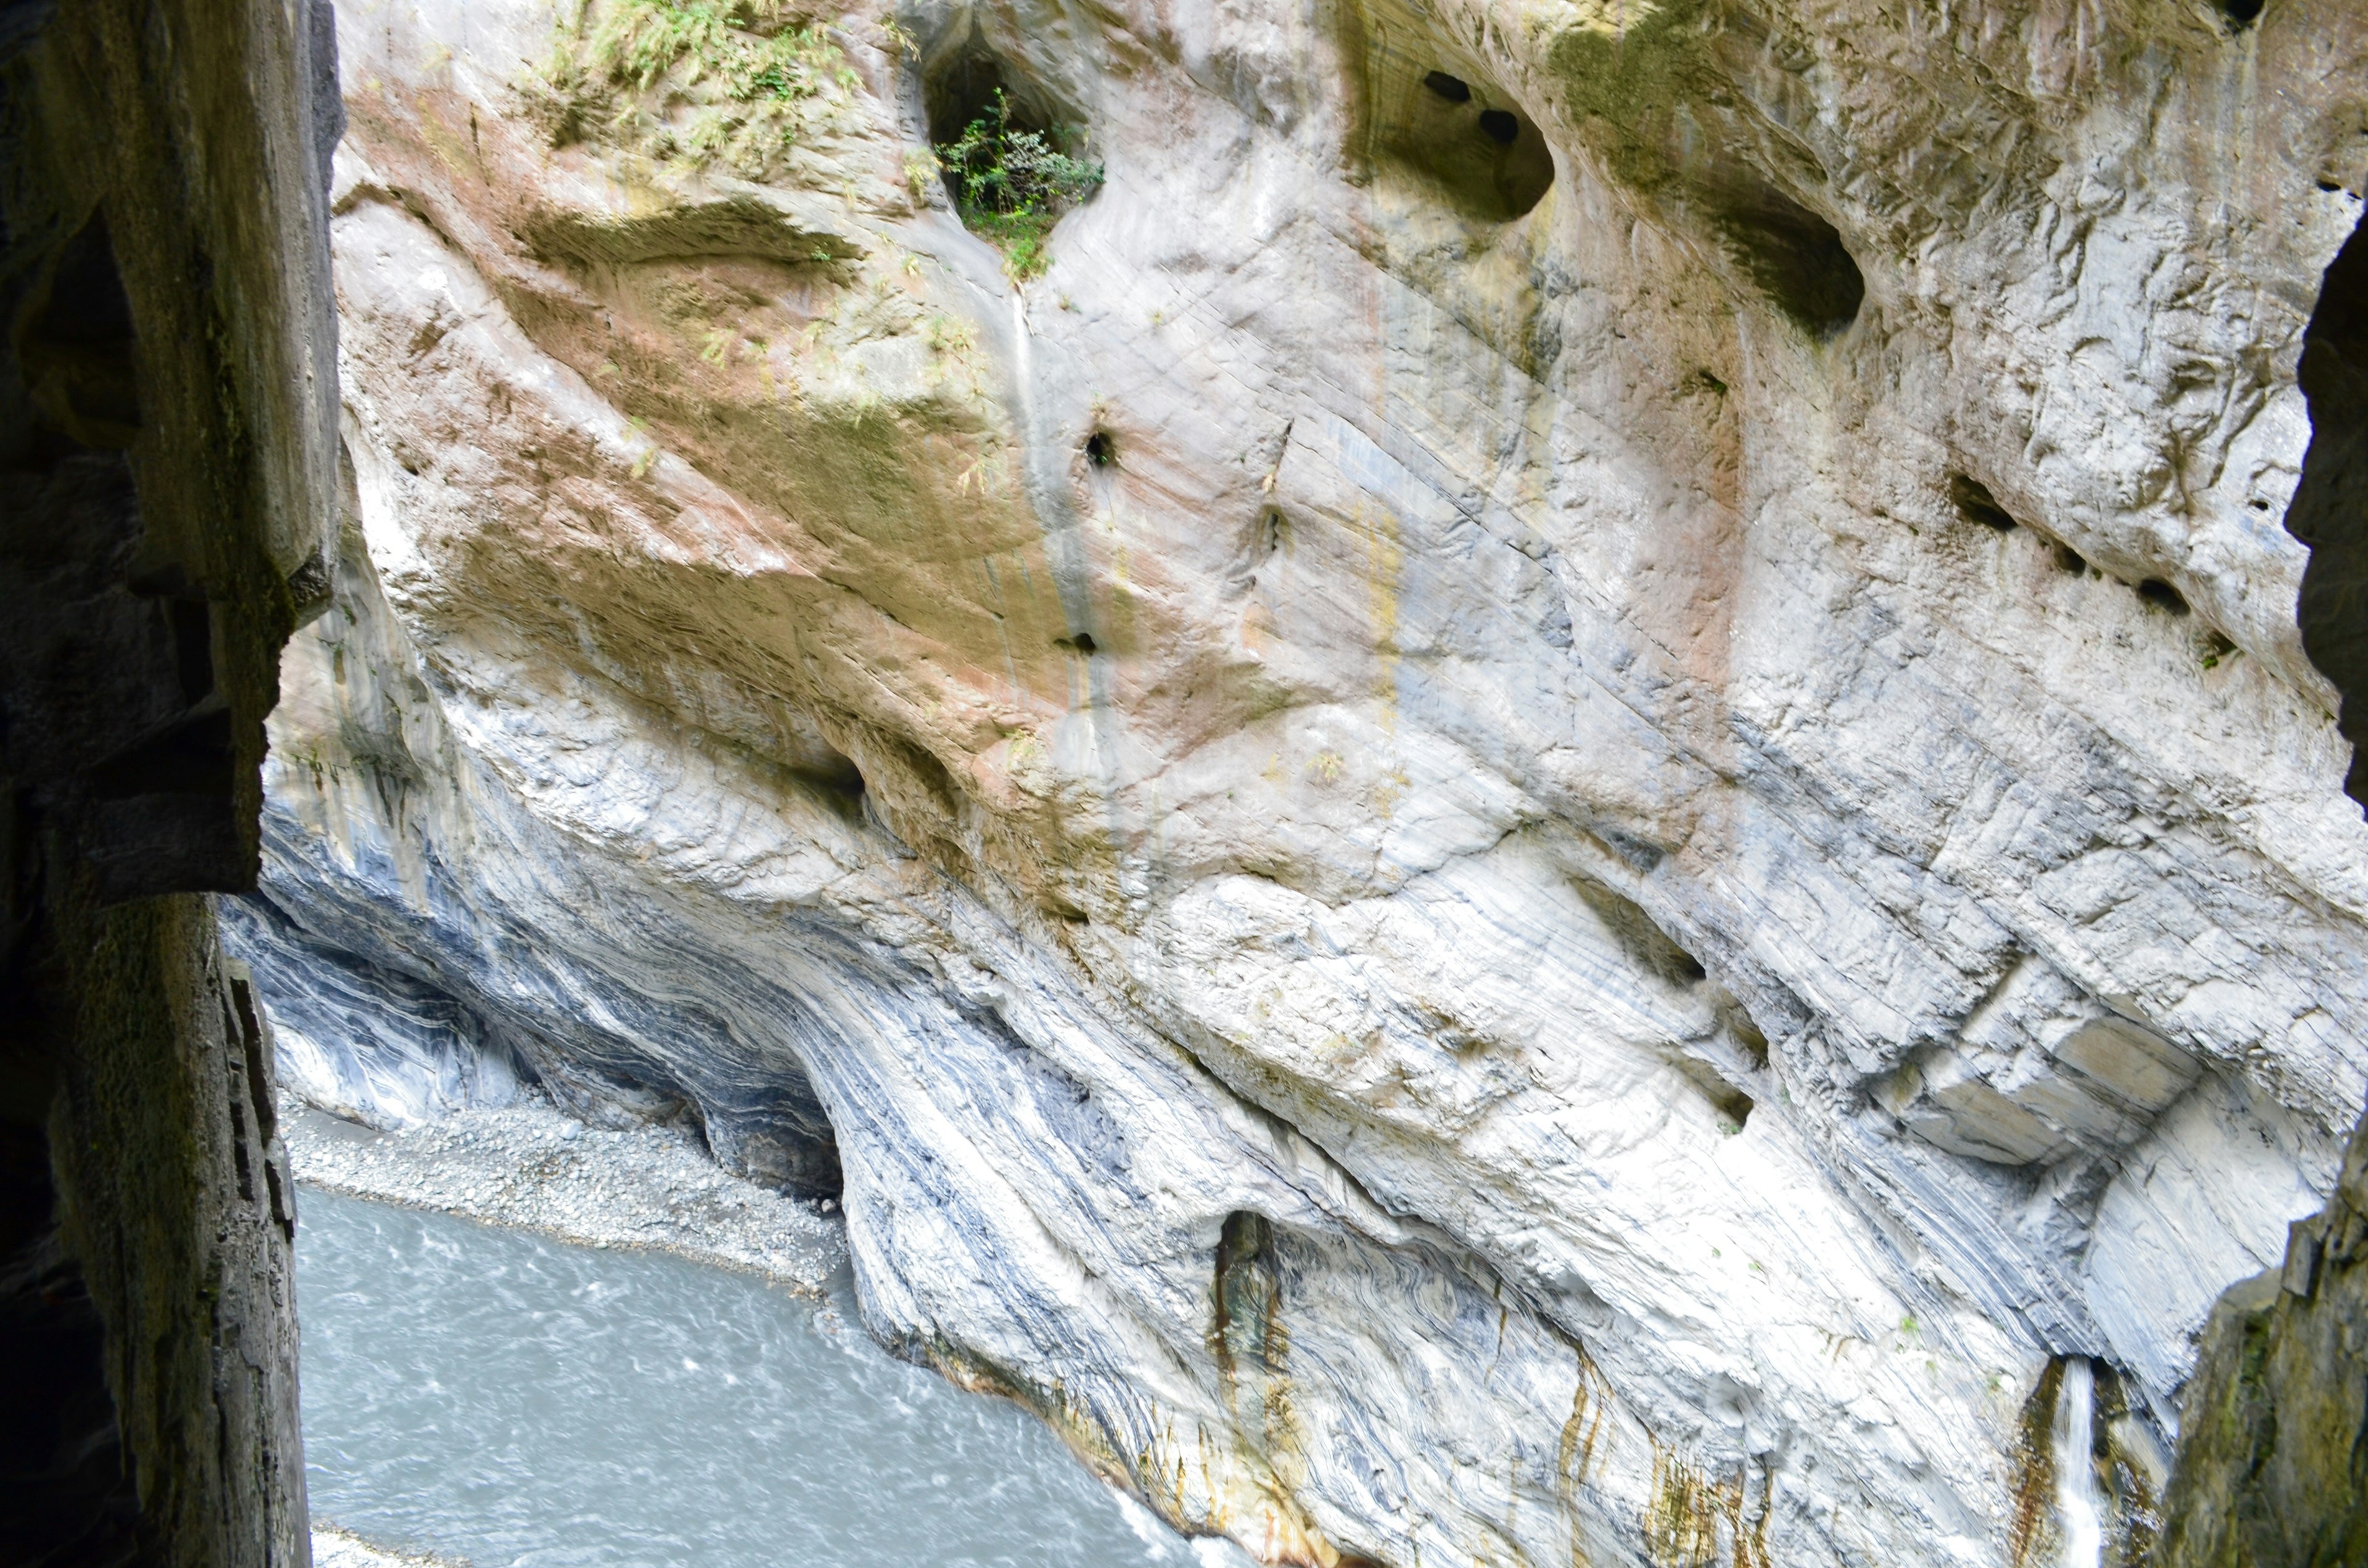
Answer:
[0,0,341,1568]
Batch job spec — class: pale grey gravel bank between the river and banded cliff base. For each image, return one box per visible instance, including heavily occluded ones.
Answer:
[279,1097,848,1295]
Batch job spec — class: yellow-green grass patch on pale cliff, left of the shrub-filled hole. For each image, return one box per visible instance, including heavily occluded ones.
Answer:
[533,0,857,180]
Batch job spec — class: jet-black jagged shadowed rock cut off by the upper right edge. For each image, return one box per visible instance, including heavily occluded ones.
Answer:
[2285,201,2368,800]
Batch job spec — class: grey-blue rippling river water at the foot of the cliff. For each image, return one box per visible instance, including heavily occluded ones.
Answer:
[296,1191,1248,1568]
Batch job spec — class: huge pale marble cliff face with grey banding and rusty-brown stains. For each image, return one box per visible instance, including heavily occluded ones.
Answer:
[234,0,2368,1566]
